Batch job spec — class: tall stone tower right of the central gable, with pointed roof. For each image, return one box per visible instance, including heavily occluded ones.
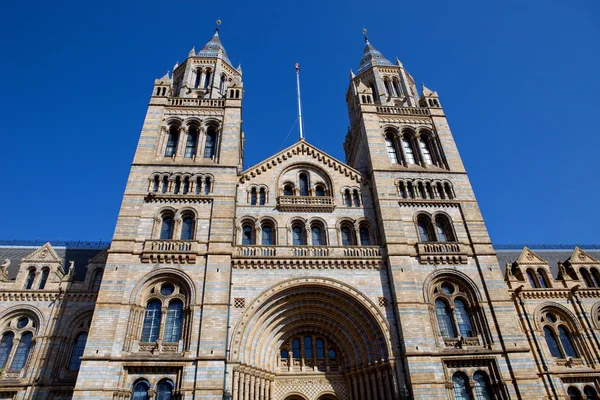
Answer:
[344,34,542,398]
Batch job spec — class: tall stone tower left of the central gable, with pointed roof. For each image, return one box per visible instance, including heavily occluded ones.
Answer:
[74,28,243,399]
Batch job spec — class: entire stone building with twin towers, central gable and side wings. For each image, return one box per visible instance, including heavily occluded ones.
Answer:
[0,30,600,400]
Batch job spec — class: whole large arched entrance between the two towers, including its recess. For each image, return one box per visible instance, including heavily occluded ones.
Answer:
[230,278,398,400]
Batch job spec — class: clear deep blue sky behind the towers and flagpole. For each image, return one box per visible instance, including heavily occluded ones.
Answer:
[0,0,600,243]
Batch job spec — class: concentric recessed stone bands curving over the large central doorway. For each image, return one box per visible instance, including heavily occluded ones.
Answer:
[229,277,394,370]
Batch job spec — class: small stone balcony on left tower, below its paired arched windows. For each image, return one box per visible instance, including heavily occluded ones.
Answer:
[142,239,199,264]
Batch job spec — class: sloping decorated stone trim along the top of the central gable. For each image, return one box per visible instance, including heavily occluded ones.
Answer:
[240,140,363,183]
